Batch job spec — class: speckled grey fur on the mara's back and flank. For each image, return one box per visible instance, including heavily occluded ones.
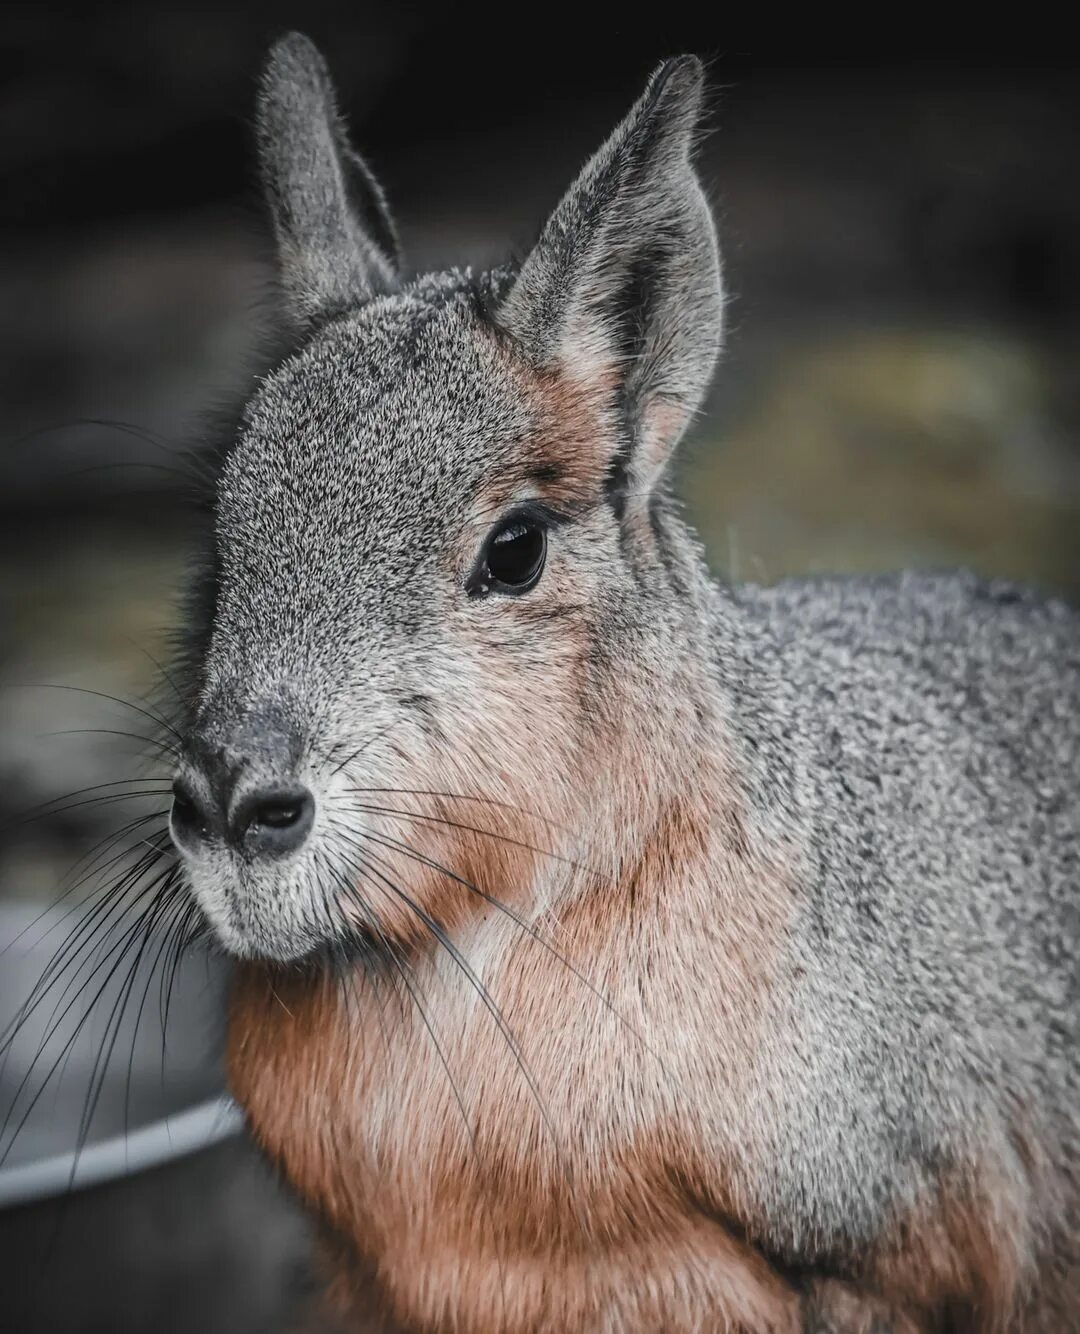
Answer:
[730,574,1080,1263]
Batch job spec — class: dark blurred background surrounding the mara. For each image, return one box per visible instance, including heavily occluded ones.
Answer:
[0,0,1080,1334]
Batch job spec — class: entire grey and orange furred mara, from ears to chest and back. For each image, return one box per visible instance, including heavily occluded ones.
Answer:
[170,36,1080,1334]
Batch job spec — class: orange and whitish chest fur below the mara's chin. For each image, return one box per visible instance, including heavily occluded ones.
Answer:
[229,869,795,1331]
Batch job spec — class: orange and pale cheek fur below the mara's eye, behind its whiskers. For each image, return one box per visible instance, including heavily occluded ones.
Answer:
[328,644,581,947]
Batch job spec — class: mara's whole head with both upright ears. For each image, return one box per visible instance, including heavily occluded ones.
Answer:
[172,36,721,960]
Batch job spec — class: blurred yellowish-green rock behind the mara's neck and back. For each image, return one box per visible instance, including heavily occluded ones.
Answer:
[684,327,1080,595]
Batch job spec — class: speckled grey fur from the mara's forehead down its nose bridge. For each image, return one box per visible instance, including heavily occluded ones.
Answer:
[197,266,552,711]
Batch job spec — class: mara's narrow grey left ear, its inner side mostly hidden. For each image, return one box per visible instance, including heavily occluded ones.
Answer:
[256,32,400,327]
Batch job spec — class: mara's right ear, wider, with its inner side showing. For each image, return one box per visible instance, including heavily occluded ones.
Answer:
[496,56,723,495]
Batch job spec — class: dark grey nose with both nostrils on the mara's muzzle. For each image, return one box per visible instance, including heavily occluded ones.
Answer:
[169,752,315,858]
